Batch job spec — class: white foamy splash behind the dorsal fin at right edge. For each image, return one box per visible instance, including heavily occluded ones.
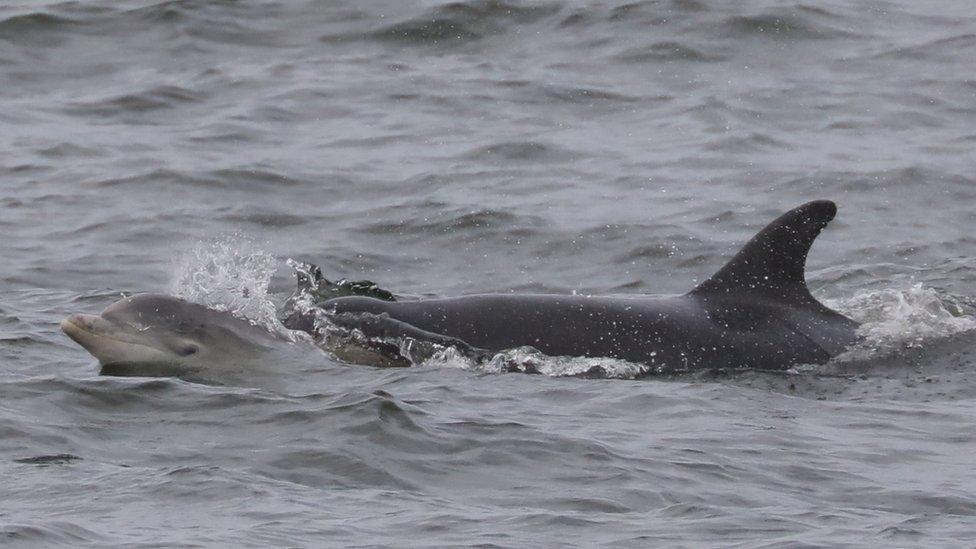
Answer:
[827,283,976,361]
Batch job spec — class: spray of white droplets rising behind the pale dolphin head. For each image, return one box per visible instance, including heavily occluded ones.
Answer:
[171,235,289,334]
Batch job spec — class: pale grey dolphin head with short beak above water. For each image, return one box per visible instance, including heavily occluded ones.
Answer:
[61,294,275,377]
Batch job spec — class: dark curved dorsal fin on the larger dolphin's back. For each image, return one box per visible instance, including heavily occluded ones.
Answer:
[691,200,837,303]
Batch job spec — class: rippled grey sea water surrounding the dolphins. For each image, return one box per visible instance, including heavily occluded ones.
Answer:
[0,0,976,547]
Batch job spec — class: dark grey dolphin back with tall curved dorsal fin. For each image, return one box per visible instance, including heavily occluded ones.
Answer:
[294,201,857,372]
